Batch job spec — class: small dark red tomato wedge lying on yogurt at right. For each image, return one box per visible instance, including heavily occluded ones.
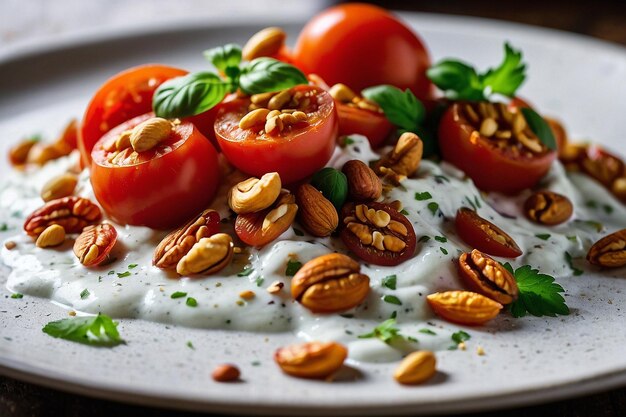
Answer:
[454,207,522,258]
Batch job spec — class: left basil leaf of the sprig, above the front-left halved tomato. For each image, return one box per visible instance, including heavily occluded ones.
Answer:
[152,72,232,119]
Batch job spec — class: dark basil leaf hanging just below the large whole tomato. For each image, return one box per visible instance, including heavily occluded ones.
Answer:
[361,85,425,132]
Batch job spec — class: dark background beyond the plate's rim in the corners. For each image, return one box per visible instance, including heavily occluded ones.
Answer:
[0,0,626,417]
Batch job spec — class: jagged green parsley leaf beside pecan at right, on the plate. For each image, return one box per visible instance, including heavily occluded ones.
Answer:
[503,263,569,317]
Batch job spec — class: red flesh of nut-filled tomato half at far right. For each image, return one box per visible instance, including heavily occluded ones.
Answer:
[439,103,556,193]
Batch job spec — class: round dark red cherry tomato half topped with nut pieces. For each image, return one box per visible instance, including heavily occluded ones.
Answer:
[339,202,417,266]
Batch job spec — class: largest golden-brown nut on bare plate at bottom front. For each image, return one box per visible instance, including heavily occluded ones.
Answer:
[274,342,348,379]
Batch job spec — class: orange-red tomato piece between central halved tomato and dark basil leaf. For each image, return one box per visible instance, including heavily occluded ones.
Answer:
[335,102,394,148]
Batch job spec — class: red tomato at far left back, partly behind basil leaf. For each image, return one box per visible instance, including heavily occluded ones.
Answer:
[78,65,187,166]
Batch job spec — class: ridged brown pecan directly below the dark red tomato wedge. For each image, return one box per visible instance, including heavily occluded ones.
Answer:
[458,249,519,304]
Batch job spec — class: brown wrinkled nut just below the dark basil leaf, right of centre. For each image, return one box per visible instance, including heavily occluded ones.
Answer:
[374,132,424,184]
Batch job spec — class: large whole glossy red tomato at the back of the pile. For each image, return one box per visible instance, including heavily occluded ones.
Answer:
[293,3,432,98]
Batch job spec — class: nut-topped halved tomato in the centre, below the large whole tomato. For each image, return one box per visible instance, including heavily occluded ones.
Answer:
[215,85,337,184]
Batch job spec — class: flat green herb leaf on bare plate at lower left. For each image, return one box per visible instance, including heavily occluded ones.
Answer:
[42,314,124,347]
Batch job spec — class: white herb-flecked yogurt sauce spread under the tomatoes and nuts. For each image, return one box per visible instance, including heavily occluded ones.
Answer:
[0,136,626,361]
